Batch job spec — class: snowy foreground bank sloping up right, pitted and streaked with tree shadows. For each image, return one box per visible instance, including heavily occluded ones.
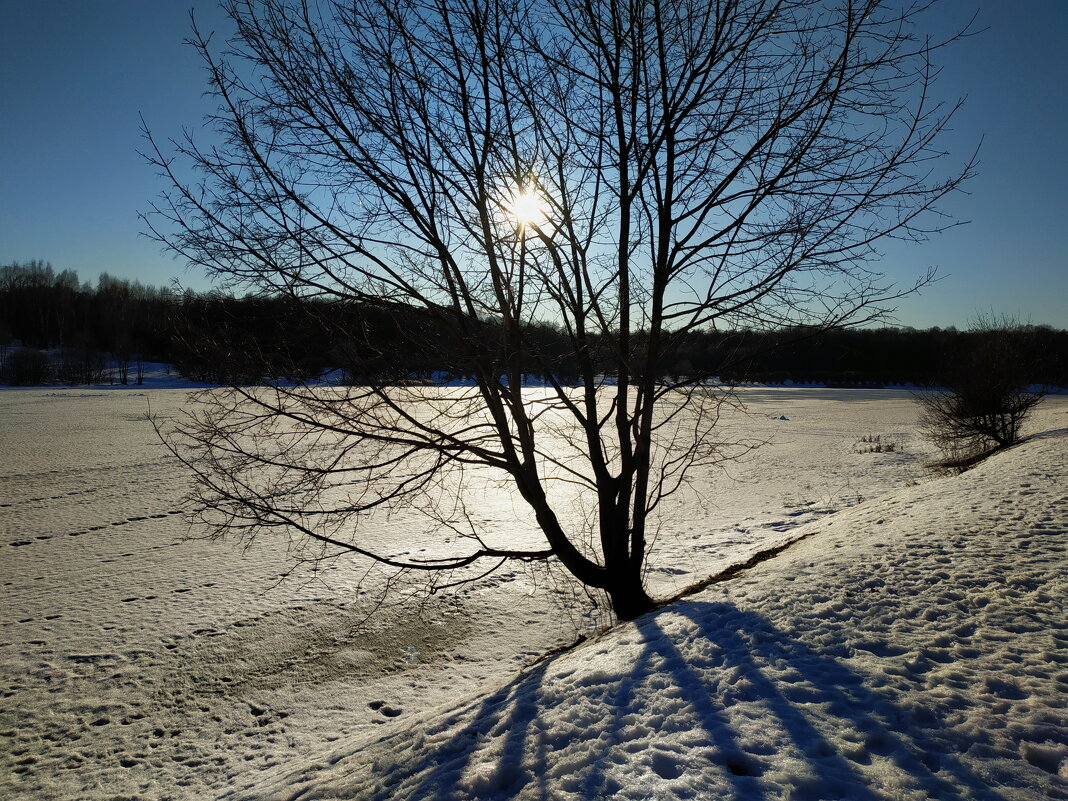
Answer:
[242,428,1068,801]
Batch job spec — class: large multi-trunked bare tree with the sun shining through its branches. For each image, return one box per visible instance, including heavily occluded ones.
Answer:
[148,0,970,618]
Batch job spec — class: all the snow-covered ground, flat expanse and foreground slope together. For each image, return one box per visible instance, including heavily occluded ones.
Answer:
[0,387,1068,800]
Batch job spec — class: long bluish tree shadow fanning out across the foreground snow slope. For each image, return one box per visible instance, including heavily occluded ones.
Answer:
[369,601,1004,801]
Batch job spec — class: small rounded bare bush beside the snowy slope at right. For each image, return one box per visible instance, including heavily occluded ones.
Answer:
[915,315,1046,469]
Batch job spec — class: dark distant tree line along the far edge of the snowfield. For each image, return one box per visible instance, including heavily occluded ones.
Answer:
[0,261,1068,386]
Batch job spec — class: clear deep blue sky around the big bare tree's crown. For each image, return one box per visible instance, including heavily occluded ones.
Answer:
[0,0,1068,328]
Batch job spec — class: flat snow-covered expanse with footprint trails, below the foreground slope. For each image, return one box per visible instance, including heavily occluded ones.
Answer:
[0,388,1068,799]
